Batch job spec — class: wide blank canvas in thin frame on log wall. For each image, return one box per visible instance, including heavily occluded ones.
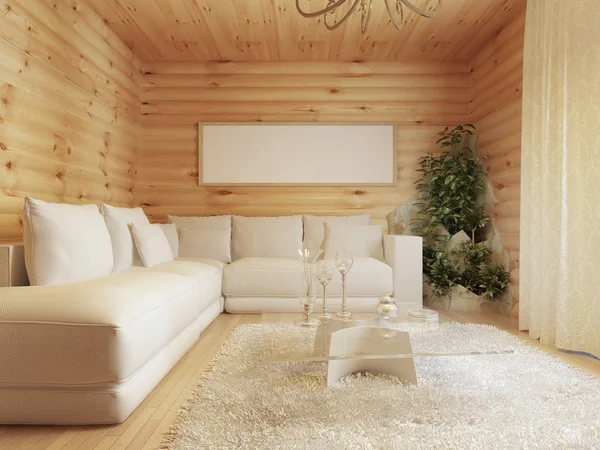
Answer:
[200,124,395,185]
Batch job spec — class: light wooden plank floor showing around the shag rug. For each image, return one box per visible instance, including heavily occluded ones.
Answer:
[0,311,600,450]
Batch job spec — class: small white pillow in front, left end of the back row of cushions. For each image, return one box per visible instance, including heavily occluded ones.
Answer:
[179,228,231,263]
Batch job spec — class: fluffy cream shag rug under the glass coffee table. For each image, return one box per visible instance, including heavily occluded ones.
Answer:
[164,324,600,450]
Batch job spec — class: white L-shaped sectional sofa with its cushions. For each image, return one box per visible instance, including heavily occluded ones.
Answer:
[0,199,422,424]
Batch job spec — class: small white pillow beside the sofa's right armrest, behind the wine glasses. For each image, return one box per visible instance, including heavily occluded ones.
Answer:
[323,222,383,261]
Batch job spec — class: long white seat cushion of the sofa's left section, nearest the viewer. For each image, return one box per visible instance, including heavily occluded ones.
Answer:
[0,265,221,388]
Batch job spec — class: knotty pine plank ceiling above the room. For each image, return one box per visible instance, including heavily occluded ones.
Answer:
[89,0,526,61]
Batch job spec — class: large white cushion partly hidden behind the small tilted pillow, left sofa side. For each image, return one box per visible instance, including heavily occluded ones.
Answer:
[100,203,150,272]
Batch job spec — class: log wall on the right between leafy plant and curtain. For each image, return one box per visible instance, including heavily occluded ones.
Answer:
[471,12,525,314]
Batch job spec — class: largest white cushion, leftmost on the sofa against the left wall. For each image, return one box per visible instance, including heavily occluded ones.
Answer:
[23,198,113,286]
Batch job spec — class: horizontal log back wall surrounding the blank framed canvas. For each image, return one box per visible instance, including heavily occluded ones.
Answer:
[135,61,470,230]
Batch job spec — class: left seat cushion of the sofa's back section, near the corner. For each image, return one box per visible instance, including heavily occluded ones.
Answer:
[223,258,303,297]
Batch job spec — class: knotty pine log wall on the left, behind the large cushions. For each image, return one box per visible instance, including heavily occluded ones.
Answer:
[0,0,142,241]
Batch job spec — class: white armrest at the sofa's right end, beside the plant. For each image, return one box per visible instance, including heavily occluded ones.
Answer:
[383,235,423,305]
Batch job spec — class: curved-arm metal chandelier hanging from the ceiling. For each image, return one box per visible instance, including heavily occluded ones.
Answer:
[296,0,442,34]
